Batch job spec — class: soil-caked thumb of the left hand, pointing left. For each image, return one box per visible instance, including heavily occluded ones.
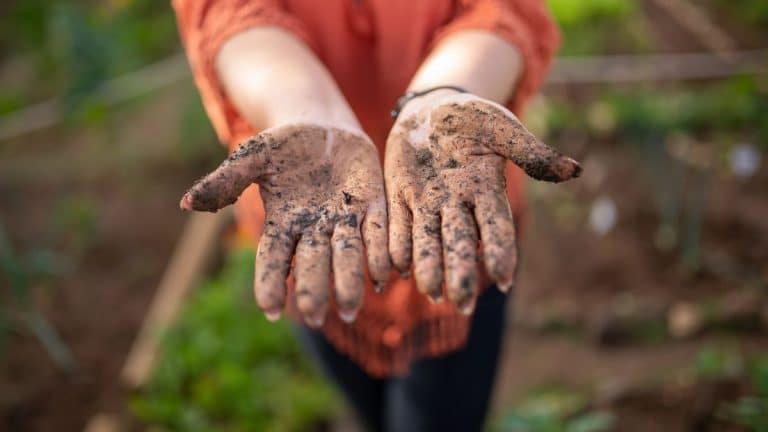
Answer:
[179,135,270,212]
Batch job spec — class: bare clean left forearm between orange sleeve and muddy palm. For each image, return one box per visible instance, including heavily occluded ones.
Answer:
[216,27,360,130]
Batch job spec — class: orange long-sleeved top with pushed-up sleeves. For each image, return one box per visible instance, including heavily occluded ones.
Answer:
[172,0,558,376]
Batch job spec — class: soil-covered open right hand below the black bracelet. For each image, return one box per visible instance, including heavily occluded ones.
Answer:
[384,92,581,314]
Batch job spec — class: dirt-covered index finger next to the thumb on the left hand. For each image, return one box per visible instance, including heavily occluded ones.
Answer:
[253,221,296,321]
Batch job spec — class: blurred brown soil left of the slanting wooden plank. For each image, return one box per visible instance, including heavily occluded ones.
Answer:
[0,86,216,431]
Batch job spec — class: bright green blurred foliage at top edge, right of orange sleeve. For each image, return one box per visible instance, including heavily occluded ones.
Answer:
[547,0,652,55]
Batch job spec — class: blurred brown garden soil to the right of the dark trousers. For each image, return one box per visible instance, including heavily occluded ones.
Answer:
[495,144,768,431]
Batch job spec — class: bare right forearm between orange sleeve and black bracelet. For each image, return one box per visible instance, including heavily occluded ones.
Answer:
[408,30,522,103]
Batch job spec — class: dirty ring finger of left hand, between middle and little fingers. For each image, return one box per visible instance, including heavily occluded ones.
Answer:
[331,215,363,322]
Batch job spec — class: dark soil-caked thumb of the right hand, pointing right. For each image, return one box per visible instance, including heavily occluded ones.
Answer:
[493,118,581,183]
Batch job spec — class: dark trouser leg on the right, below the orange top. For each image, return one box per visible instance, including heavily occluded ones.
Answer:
[385,287,507,432]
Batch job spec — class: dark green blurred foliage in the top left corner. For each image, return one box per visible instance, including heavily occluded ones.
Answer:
[0,0,178,116]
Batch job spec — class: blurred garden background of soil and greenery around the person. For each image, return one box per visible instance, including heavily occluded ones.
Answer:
[0,0,768,432]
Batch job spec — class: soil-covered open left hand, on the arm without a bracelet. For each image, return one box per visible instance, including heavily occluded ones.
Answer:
[180,124,390,327]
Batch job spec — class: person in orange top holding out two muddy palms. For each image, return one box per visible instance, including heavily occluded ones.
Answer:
[173,0,581,431]
